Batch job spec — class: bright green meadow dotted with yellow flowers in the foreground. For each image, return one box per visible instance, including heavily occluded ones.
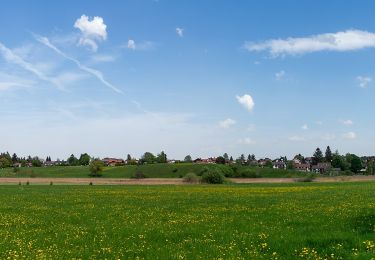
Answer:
[0,182,375,259]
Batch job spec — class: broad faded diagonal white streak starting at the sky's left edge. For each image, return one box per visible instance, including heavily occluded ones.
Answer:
[0,40,65,90]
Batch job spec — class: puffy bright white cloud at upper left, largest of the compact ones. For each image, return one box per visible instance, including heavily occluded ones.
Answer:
[74,15,107,52]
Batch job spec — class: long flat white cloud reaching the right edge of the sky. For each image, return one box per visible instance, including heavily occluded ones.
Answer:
[244,30,375,57]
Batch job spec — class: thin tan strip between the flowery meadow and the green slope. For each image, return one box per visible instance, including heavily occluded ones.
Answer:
[0,176,375,185]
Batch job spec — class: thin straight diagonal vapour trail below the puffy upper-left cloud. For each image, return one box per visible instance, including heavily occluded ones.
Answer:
[34,35,123,94]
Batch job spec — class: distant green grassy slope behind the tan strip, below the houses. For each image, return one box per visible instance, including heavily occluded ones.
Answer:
[0,163,306,178]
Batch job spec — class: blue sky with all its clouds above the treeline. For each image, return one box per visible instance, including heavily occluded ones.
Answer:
[0,0,375,159]
